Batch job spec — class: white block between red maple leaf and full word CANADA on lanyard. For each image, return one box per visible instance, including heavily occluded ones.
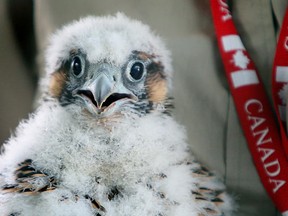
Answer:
[231,70,259,88]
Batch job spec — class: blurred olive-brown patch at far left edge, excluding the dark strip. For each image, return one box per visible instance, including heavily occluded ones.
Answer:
[0,0,34,145]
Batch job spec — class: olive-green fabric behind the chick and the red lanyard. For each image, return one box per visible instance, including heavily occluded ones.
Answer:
[0,0,288,216]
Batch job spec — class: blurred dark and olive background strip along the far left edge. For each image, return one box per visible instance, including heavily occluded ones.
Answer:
[0,0,38,143]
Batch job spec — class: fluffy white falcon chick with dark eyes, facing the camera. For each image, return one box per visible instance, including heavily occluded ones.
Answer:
[0,13,233,216]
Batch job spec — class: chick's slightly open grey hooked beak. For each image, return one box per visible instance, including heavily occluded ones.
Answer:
[77,73,137,113]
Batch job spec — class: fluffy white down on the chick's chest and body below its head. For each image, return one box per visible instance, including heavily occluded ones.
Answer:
[0,107,206,215]
